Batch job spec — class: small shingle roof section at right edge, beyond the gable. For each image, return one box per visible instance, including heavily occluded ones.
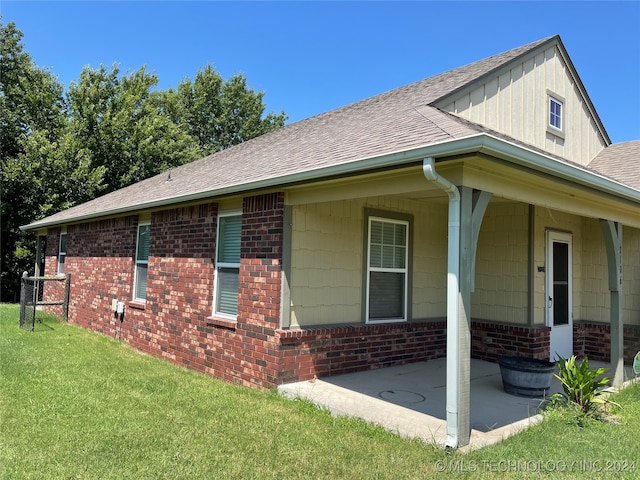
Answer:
[588,140,640,190]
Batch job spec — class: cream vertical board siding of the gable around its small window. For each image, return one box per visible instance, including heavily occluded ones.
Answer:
[436,47,605,165]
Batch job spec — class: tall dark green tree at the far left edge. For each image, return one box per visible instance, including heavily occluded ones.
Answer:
[0,22,71,301]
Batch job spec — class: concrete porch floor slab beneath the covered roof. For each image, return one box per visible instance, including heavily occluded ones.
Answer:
[278,358,633,449]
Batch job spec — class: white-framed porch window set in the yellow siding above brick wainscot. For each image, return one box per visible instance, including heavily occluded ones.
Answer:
[366,216,410,322]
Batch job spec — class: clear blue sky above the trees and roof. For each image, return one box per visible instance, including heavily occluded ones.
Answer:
[0,0,640,142]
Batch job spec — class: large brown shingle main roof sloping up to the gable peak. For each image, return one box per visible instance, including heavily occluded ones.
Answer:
[26,36,584,229]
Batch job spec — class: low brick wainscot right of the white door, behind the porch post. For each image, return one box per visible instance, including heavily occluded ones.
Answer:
[573,321,640,364]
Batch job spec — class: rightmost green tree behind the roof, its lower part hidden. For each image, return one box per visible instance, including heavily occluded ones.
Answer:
[158,65,287,155]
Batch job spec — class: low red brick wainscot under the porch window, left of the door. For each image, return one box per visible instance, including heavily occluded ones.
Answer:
[278,321,446,383]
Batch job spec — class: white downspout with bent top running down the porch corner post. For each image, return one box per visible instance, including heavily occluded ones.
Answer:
[422,157,460,448]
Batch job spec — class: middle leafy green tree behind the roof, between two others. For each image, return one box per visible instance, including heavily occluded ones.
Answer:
[67,66,200,192]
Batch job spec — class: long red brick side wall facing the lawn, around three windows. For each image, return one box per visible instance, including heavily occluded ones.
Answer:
[40,193,284,388]
